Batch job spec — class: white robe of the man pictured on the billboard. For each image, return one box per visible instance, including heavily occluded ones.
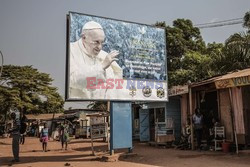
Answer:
[69,38,122,99]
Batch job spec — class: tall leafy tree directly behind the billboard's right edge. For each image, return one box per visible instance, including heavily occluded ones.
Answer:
[156,19,206,86]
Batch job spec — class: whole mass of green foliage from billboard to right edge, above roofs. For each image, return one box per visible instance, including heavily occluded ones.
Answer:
[156,12,250,87]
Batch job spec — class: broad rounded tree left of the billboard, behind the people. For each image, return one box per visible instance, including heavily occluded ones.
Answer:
[0,65,64,118]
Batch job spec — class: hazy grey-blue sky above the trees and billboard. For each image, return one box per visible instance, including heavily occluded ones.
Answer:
[0,0,250,108]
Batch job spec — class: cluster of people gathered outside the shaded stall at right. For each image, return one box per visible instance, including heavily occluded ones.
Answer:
[183,108,220,150]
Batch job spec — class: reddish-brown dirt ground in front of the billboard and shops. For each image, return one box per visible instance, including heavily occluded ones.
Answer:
[0,137,250,167]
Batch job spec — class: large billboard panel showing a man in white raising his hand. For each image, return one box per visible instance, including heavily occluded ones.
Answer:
[66,12,168,101]
